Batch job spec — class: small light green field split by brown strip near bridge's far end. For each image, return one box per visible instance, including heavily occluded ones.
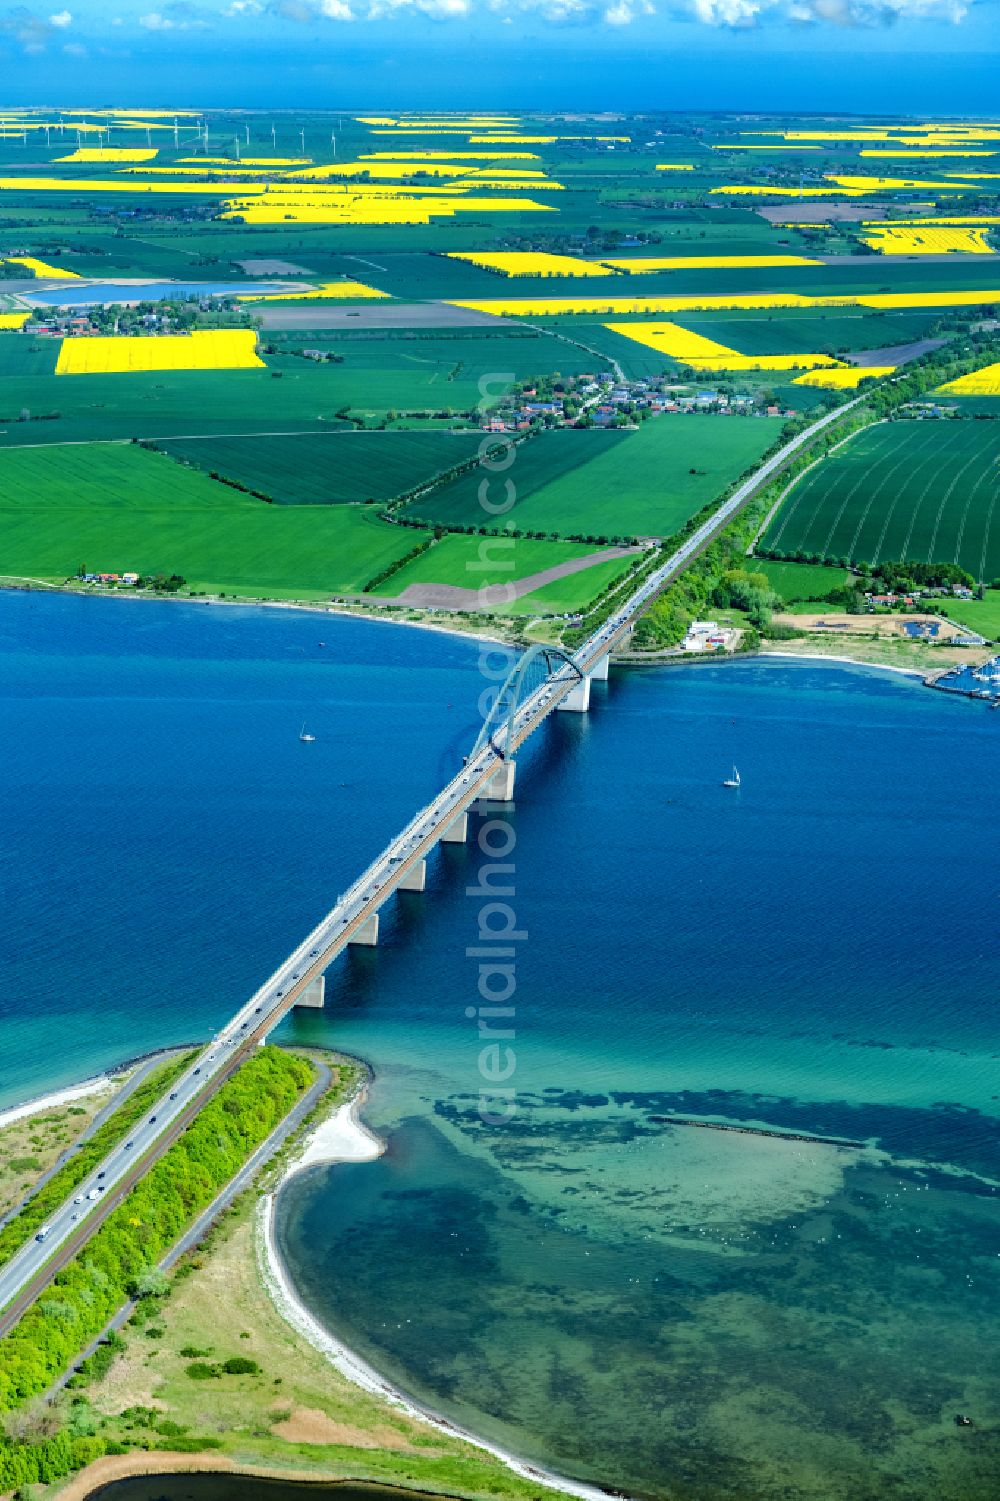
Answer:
[372,528,631,614]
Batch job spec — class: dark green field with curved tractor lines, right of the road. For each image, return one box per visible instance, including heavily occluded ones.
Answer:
[761,422,1000,579]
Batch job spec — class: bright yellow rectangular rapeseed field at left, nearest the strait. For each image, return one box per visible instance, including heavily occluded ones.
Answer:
[56,329,266,375]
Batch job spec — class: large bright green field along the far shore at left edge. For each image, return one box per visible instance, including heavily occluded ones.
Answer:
[0,444,420,597]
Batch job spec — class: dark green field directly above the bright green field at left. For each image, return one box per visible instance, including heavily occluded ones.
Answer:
[161,431,480,506]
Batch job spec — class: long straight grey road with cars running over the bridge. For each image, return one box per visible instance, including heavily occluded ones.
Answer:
[0,396,865,1334]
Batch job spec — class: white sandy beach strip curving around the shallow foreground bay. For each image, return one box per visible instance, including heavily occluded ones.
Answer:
[255,1084,611,1501]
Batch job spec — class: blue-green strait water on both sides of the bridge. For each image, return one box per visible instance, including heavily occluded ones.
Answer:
[0,594,1000,1501]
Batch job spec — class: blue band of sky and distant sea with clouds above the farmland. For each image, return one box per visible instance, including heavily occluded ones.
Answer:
[0,0,1000,114]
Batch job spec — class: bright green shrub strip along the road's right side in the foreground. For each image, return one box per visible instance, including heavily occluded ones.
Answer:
[0,1048,312,1416]
